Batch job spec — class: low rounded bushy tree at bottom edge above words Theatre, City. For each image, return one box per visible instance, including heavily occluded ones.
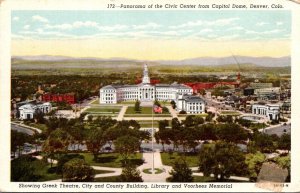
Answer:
[62,158,95,182]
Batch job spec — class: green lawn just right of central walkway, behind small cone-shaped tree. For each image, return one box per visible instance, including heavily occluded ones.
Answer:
[160,152,199,167]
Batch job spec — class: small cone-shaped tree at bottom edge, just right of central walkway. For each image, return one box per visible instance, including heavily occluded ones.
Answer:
[170,158,193,182]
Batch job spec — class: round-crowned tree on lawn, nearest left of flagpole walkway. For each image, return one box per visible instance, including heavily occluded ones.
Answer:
[114,135,141,165]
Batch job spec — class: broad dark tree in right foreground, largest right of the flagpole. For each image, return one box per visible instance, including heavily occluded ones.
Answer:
[199,142,247,181]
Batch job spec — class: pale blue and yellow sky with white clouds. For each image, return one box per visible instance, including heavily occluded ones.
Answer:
[11,10,291,60]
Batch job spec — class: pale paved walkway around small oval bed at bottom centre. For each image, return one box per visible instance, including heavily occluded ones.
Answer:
[138,149,172,182]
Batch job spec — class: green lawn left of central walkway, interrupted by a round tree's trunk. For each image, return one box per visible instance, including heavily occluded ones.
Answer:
[80,153,143,168]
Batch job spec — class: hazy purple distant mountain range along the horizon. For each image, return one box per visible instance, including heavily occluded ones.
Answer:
[12,55,291,67]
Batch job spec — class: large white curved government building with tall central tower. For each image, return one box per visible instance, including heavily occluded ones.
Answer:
[99,64,205,114]
